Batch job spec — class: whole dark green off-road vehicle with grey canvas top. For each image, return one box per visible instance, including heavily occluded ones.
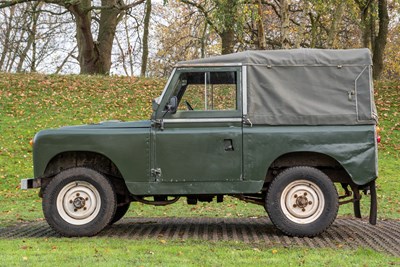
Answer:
[21,49,379,237]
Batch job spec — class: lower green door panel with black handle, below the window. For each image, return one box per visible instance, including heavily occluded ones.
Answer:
[152,120,243,183]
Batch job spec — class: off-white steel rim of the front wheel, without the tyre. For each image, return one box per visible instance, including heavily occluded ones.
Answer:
[57,181,101,225]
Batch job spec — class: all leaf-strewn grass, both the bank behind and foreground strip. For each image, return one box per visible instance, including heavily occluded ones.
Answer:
[0,73,400,266]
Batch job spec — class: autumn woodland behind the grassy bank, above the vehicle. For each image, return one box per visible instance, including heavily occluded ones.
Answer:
[0,0,400,79]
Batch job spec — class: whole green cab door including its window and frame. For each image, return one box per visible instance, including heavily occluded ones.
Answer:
[152,67,243,186]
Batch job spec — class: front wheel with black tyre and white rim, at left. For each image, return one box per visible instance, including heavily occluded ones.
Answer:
[42,167,117,236]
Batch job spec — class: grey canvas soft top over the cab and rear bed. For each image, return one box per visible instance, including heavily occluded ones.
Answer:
[177,49,377,125]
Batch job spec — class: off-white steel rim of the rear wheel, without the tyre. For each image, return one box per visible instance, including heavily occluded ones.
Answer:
[280,180,325,224]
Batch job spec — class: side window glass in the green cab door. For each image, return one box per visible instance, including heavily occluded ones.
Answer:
[174,71,237,111]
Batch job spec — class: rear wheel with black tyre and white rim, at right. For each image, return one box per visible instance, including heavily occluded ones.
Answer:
[265,167,339,237]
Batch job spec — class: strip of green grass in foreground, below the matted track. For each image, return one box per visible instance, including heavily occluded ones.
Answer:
[0,238,400,266]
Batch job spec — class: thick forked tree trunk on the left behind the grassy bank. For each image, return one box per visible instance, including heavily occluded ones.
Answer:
[0,0,144,74]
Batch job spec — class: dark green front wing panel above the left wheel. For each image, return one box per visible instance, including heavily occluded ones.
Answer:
[33,127,150,182]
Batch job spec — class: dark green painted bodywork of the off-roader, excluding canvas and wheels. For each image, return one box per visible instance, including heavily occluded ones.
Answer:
[33,63,377,195]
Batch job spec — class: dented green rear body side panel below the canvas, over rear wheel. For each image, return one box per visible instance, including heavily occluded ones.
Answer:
[243,125,377,185]
